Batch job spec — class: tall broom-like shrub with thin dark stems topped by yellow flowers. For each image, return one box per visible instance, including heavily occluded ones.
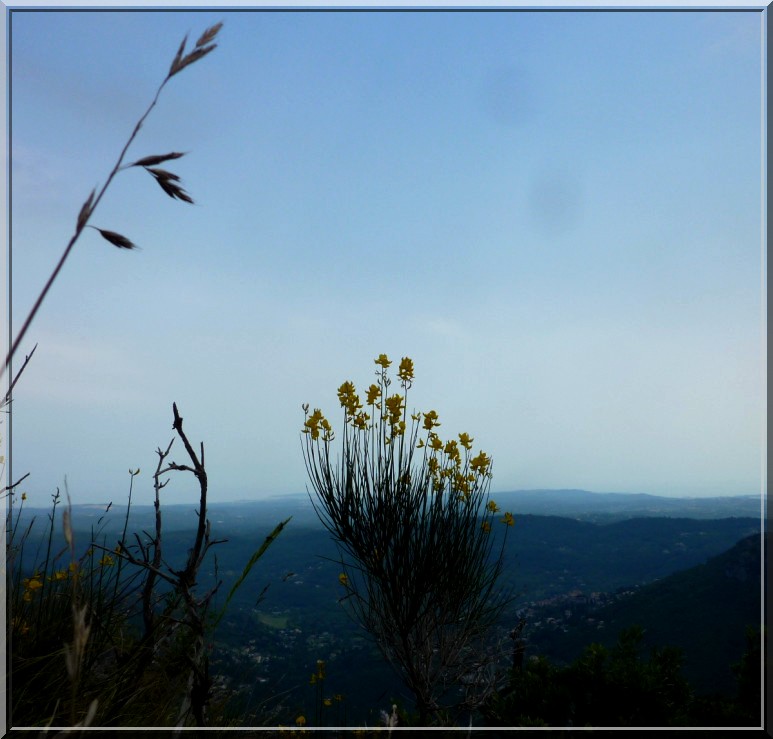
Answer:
[302,354,514,722]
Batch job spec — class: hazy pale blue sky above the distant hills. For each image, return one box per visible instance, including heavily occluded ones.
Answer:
[0,10,767,506]
